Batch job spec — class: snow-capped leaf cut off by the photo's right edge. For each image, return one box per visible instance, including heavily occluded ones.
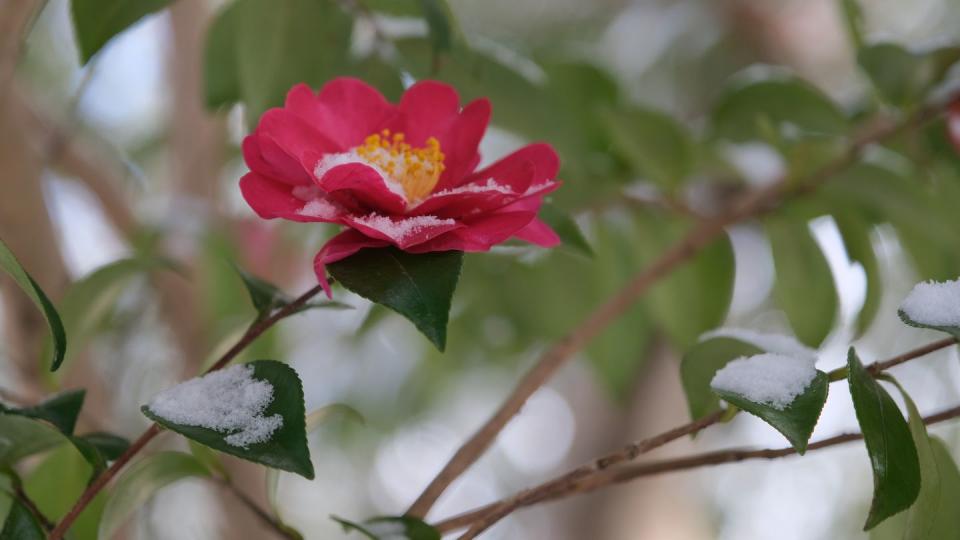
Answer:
[897,279,960,339]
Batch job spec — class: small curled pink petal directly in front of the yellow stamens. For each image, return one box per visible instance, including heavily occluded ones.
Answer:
[317,162,407,214]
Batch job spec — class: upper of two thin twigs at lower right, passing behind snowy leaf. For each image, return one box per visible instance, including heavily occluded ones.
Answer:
[439,338,957,538]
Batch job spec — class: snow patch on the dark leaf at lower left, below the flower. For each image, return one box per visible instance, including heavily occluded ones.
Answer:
[147,365,283,448]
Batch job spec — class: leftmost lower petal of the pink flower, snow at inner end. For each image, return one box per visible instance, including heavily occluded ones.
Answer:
[240,172,344,223]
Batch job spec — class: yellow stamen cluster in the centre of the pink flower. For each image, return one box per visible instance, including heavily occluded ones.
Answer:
[356,129,444,202]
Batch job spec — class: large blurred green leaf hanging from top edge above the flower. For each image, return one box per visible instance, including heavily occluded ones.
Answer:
[235,0,353,120]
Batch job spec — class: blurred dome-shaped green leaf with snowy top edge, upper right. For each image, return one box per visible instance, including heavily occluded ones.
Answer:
[711,76,848,142]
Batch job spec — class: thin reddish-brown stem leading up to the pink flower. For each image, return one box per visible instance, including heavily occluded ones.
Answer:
[50,285,323,540]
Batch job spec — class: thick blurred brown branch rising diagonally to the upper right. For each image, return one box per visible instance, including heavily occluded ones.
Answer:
[407,87,956,518]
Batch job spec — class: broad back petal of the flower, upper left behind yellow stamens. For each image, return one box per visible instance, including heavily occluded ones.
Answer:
[285,77,398,152]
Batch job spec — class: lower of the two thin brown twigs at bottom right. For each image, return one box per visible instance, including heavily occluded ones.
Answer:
[446,400,960,540]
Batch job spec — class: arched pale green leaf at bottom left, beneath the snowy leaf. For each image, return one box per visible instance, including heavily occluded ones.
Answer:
[98,452,210,538]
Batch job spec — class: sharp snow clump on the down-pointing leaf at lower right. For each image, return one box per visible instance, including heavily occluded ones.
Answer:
[710,353,817,410]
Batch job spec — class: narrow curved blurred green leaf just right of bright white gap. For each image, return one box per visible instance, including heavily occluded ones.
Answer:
[833,211,883,336]
